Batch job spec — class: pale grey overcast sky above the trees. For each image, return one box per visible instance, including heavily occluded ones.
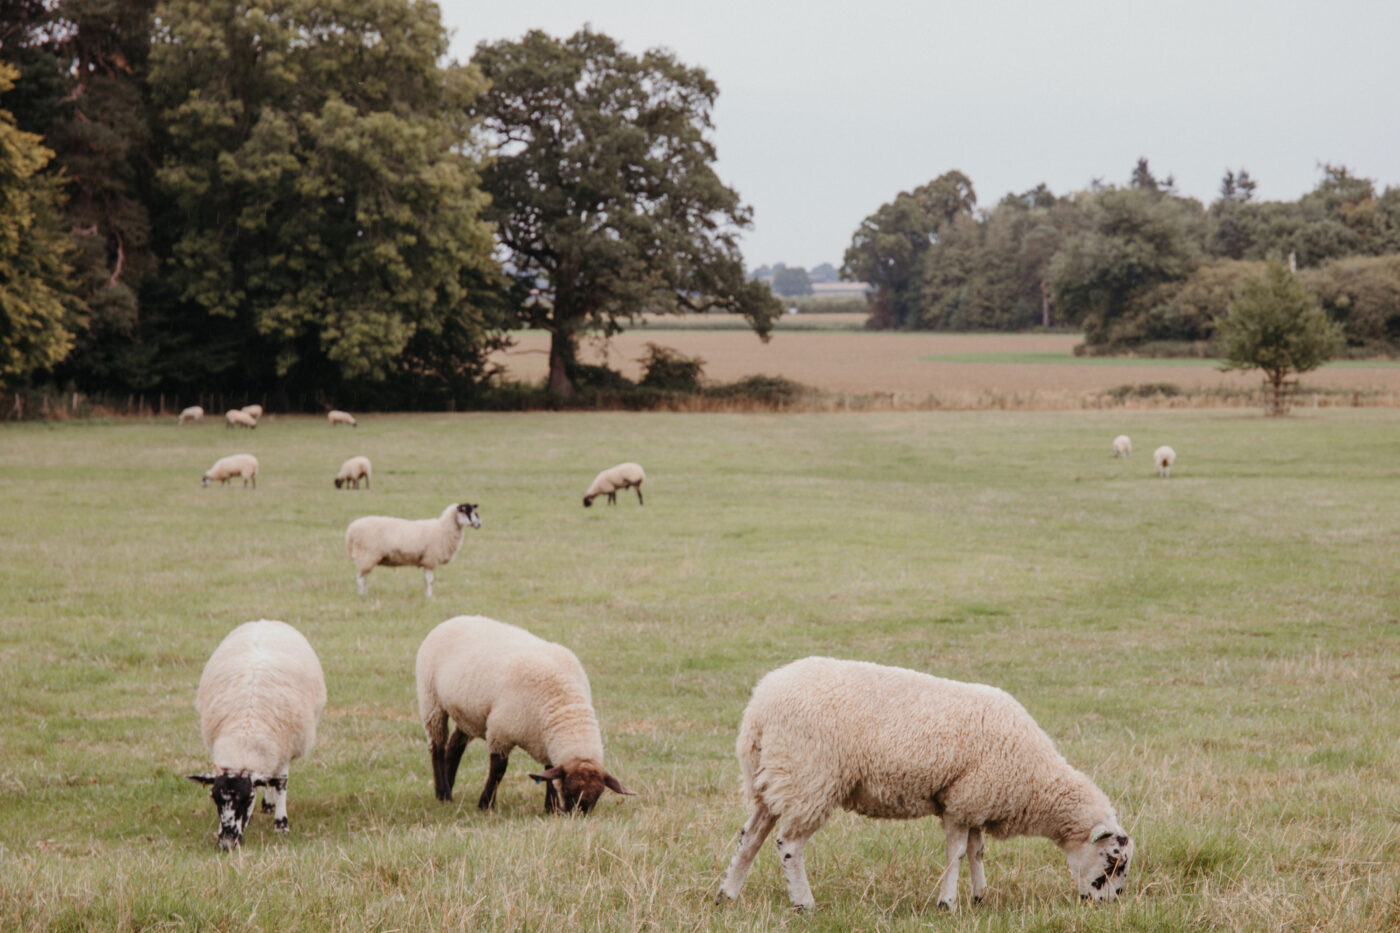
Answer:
[440,0,1400,269]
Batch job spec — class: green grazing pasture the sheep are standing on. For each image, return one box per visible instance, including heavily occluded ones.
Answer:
[0,409,1400,932]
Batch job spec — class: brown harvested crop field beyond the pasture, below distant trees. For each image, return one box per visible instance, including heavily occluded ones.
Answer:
[496,318,1400,403]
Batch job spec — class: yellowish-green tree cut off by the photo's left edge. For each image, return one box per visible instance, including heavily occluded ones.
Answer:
[0,63,73,387]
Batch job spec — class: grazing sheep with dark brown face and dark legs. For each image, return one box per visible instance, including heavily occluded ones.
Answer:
[416,615,633,813]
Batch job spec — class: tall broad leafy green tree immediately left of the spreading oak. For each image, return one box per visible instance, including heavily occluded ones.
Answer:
[150,0,494,392]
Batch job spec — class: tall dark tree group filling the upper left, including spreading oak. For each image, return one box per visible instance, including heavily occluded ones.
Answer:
[0,0,781,408]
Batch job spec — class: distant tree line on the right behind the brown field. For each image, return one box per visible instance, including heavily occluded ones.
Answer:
[841,158,1400,356]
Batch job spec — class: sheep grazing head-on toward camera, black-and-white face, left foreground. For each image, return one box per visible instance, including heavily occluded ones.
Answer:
[188,619,326,849]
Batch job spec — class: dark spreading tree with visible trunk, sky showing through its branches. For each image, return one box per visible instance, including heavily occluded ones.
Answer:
[470,28,781,396]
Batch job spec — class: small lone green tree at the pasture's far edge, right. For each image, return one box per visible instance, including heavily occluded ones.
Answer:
[1217,262,1341,415]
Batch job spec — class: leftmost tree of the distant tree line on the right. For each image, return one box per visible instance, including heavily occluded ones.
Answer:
[841,171,977,328]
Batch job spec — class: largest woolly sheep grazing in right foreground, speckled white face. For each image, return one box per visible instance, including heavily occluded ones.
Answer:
[717,657,1133,909]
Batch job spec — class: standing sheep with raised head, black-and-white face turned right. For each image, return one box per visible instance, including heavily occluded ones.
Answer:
[346,502,482,597]
